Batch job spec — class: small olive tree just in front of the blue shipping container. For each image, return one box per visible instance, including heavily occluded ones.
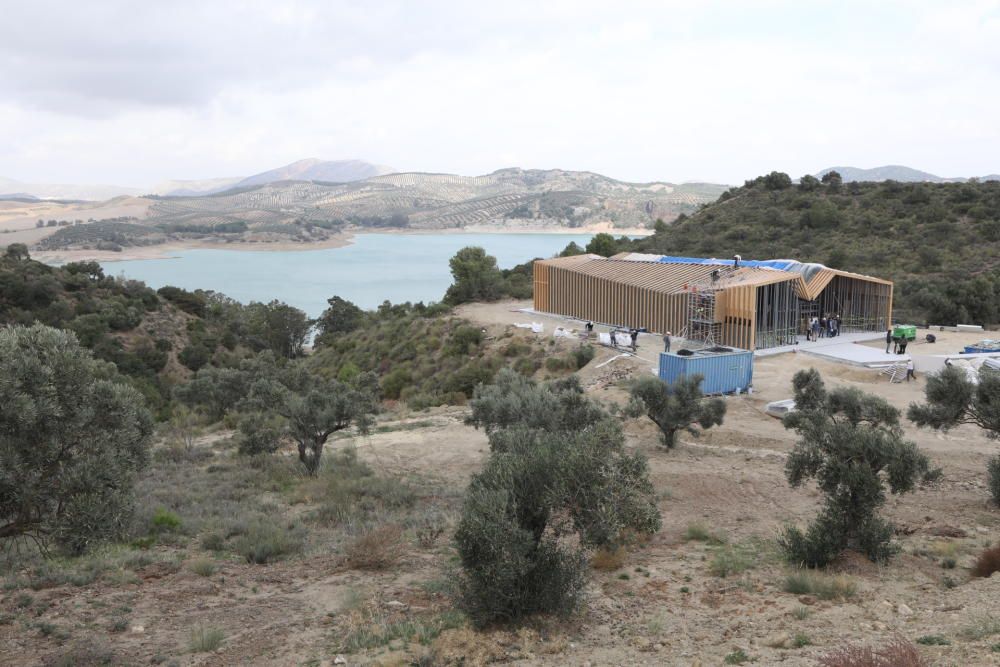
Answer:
[626,375,726,449]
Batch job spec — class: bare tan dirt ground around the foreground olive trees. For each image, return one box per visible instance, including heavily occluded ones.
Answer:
[0,303,1000,667]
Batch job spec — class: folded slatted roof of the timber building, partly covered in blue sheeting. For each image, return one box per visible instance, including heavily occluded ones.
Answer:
[541,253,892,300]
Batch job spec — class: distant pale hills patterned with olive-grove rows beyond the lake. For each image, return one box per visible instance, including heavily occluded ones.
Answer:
[29,168,724,250]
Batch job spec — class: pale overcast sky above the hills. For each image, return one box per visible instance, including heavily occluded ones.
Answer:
[0,0,1000,187]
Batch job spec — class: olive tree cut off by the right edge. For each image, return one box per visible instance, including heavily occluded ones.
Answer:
[907,366,1000,505]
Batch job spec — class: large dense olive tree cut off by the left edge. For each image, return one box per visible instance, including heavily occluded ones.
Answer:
[0,325,153,553]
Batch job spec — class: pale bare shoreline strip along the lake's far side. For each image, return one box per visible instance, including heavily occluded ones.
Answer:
[31,225,652,264]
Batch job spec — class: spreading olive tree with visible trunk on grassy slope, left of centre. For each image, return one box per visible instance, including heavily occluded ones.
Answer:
[241,365,378,475]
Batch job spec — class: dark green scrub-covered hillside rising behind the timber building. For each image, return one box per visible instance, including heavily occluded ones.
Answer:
[634,174,1000,324]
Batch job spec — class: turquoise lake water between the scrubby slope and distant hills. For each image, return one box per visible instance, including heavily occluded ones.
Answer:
[103,234,591,317]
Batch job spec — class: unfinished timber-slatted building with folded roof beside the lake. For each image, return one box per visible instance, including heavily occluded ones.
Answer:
[534,253,892,350]
